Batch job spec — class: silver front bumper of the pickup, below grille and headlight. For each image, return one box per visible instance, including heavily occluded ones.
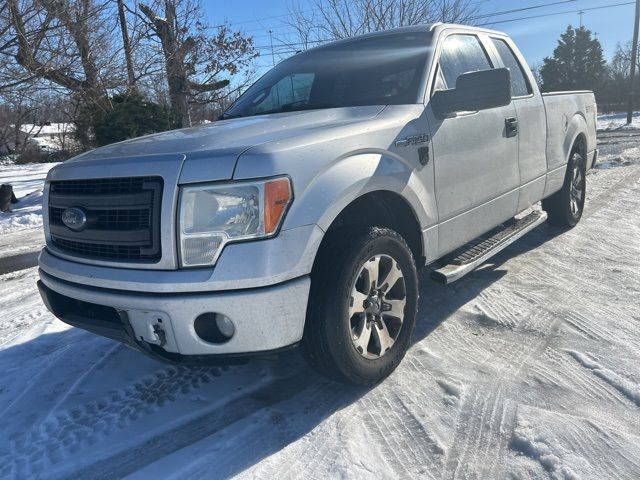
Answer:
[38,269,310,362]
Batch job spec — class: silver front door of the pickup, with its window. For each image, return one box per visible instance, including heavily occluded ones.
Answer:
[425,30,520,256]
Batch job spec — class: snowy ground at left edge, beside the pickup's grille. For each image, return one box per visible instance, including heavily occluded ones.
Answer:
[0,161,56,258]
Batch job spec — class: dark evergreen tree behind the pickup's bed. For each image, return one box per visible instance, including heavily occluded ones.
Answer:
[540,25,607,92]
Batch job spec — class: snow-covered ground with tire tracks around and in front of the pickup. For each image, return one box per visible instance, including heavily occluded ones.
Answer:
[0,133,640,479]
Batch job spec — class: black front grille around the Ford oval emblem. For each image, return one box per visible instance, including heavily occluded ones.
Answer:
[49,177,162,261]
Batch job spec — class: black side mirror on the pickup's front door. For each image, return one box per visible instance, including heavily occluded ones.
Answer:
[431,68,511,118]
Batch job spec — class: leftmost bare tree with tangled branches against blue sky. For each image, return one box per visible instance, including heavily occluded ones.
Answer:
[0,0,122,146]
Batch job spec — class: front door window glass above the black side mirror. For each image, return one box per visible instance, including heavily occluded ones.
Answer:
[439,35,491,88]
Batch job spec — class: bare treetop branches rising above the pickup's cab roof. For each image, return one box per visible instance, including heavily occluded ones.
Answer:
[281,0,478,50]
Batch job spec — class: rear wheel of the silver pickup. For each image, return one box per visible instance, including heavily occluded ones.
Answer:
[542,152,587,228]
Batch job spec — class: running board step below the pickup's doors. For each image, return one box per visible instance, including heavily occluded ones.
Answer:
[431,211,547,285]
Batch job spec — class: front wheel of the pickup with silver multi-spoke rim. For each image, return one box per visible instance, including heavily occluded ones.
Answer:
[302,228,418,385]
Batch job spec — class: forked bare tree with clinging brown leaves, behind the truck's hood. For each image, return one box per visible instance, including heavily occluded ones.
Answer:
[138,0,257,127]
